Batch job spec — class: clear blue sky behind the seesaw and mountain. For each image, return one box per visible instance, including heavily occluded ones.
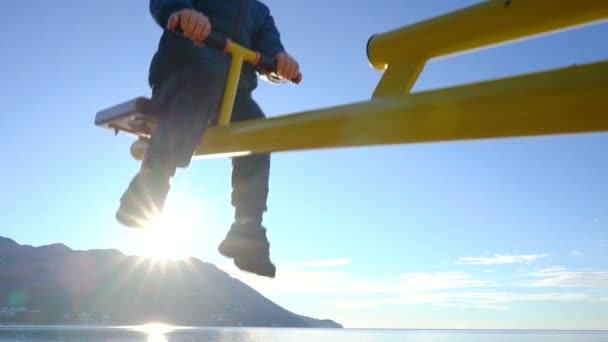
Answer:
[0,0,608,329]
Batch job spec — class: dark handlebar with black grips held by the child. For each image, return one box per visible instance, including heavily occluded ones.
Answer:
[167,16,302,84]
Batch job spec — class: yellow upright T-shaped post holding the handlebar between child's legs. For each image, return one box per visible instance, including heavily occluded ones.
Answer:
[218,42,257,126]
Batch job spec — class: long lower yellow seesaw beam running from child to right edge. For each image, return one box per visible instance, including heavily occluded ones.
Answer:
[195,62,608,155]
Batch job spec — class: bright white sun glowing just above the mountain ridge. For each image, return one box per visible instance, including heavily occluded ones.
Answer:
[141,201,201,260]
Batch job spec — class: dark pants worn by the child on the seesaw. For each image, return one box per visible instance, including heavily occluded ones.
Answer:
[143,66,270,219]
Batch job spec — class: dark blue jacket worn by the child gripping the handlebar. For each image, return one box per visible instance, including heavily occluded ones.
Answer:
[149,0,284,91]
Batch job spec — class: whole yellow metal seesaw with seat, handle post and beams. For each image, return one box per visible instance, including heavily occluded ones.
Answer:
[95,0,608,160]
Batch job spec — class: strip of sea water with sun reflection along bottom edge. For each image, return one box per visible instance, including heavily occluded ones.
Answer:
[0,326,608,342]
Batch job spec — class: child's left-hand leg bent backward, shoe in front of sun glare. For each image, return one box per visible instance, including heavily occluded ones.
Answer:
[116,67,225,227]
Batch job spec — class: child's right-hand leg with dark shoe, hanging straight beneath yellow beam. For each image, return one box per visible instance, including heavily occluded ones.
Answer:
[219,91,276,277]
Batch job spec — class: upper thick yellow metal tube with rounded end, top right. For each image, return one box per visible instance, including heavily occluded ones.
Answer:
[368,0,608,70]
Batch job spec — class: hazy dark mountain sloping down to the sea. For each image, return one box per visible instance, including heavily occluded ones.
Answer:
[0,236,342,328]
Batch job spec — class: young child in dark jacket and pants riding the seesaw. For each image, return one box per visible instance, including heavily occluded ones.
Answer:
[116,0,299,278]
